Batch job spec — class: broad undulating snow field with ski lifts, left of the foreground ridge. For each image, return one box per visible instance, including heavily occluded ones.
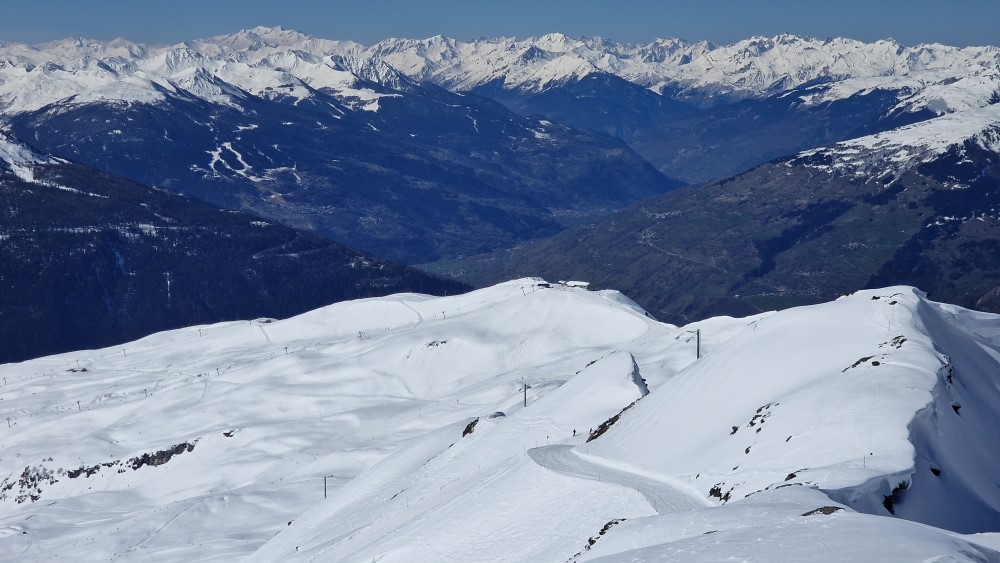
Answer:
[0,280,672,560]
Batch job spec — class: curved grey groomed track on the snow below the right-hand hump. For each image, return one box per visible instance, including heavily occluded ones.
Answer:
[528,445,714,514]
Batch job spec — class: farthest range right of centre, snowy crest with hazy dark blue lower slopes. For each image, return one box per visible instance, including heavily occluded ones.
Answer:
[362,34,1000,183]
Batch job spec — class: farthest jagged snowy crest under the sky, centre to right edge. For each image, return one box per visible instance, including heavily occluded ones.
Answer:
[368,34,1000,108]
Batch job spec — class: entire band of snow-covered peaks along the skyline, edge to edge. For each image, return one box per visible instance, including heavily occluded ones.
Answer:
[0,27,1000,118]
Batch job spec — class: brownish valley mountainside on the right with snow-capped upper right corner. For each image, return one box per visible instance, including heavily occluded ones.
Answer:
[435,105,1000,320]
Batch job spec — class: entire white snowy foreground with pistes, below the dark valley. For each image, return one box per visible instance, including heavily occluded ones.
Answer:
[0,278,1000,562]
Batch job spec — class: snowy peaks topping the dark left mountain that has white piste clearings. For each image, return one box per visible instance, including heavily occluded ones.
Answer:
[0,27,402,115]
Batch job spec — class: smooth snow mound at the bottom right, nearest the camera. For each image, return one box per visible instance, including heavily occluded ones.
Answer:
[578,487,1000,563]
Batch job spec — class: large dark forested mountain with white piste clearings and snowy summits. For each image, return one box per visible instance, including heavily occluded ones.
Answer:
[0,29,680,262]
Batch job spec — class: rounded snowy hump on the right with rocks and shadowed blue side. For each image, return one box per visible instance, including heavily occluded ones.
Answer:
[591,287,1000,531]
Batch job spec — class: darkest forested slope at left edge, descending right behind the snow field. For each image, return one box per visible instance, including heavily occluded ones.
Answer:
[0,134,466,362]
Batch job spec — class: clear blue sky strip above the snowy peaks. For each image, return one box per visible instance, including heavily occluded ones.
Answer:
[0,0,1000,46]
